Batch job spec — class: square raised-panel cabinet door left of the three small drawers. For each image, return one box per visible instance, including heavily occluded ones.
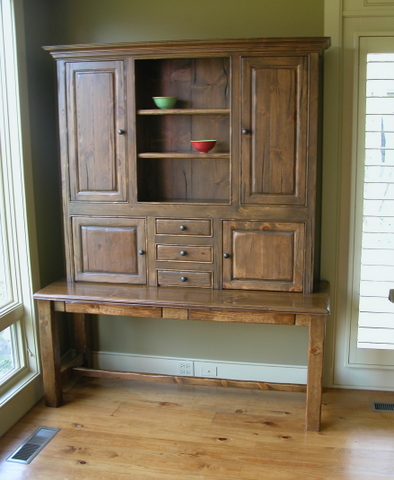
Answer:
[72,217,146,284]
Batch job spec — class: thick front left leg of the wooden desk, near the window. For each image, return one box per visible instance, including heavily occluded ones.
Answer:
[37,300,63,407]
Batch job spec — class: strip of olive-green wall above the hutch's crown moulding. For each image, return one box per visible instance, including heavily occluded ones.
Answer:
[54,0,324,43]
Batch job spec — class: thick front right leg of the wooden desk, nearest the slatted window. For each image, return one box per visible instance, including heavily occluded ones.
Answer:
[305,315,326,432]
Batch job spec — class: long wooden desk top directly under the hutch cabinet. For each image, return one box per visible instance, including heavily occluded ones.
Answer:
[34,280,330,315]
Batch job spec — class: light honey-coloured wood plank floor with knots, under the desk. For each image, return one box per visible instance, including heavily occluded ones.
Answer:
[0,378,394,480]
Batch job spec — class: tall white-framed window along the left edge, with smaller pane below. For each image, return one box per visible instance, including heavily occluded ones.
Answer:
[0,0,38,407]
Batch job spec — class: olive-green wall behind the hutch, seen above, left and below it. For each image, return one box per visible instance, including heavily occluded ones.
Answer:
[25,0,324,364]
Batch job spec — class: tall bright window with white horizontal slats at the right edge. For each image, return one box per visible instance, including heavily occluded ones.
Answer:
[355,37,394,349]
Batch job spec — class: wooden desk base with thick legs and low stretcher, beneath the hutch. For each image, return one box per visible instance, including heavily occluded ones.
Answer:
[34,280,330,431]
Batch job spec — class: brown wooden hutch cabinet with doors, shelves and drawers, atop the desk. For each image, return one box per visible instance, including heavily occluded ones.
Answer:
[45,38,329,293]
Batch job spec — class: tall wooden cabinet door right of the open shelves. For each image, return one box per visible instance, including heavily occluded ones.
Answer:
[241,57,308,205]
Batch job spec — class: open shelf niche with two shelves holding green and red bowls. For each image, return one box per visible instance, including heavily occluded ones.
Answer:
[135,57,231,203]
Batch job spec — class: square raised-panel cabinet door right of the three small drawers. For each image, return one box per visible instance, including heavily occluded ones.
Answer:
[223,221,305,292]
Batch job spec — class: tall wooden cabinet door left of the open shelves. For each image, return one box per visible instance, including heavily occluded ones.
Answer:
[66,61,127,202]
